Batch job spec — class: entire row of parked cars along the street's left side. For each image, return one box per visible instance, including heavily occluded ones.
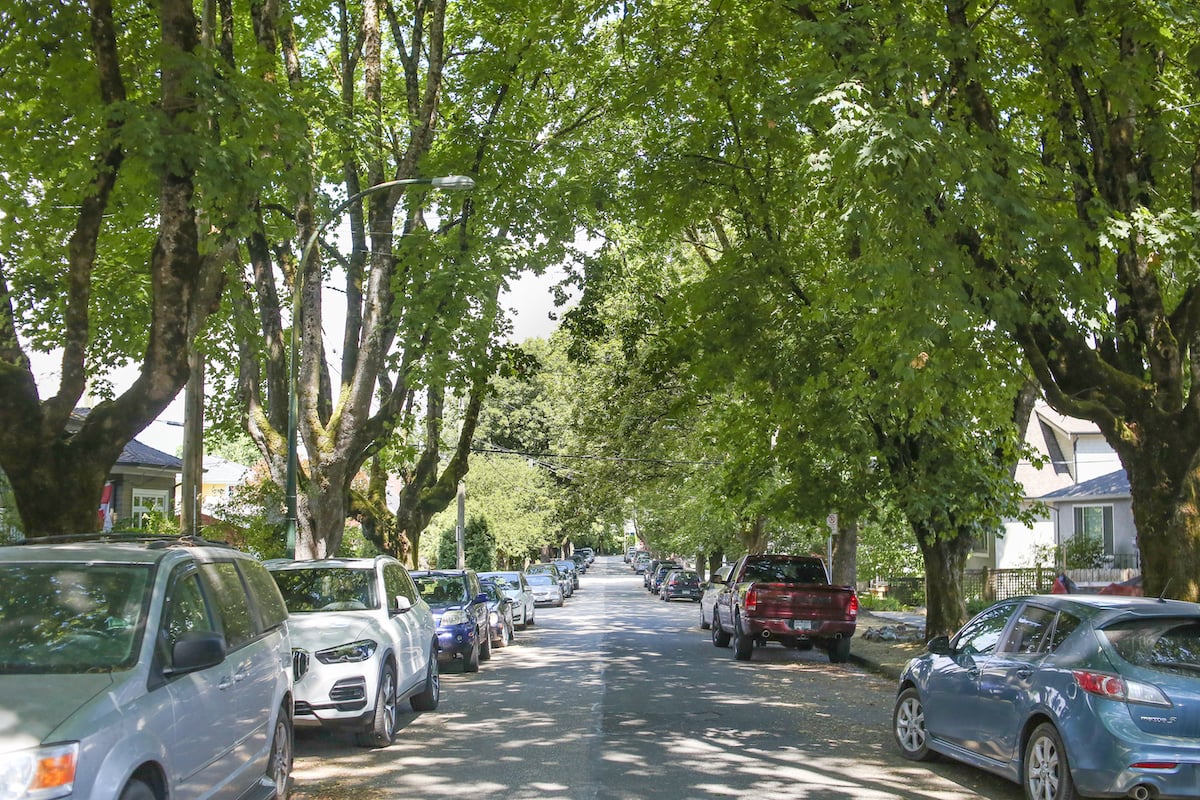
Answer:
[0,536,589,800]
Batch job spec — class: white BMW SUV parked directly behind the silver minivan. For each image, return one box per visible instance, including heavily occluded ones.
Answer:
[266,555,442,747]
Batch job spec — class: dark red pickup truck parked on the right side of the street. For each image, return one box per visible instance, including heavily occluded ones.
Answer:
[712,554,858,663]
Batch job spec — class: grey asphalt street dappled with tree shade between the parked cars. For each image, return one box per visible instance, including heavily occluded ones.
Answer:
[285,557,1021,800]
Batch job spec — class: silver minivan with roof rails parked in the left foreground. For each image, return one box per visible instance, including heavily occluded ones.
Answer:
[0,536,293,800]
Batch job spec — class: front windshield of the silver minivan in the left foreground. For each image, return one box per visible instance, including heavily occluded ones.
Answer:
[0,563,152,675]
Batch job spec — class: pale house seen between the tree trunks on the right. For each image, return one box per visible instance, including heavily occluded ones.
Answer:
[988,402,1139,569]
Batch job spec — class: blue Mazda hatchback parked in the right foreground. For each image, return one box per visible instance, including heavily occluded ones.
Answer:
[892,595,1200,800]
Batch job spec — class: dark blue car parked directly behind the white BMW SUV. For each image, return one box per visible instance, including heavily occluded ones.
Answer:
[413,570,492,672]
